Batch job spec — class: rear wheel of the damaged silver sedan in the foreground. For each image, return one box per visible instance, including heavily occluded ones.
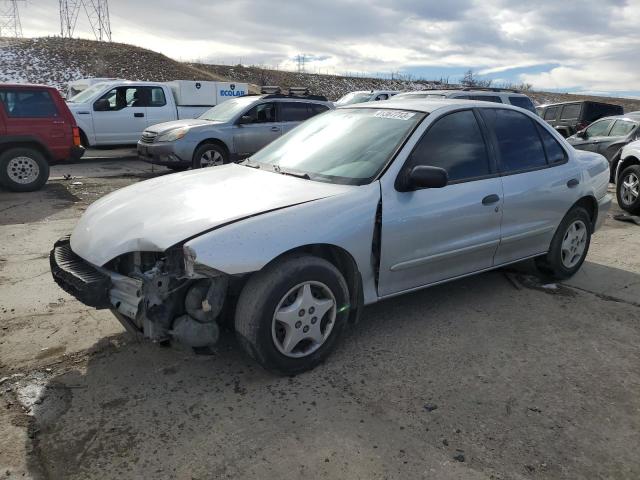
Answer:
[536,207,593,280]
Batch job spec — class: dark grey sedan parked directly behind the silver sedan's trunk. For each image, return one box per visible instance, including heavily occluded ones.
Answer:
[567,114,640,181]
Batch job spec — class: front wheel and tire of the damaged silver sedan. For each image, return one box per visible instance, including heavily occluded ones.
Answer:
[235,255,349,375]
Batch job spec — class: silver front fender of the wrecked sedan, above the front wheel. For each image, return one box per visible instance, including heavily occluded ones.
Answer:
[185,182,380,303]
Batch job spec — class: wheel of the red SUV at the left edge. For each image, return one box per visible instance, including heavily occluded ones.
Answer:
[0,148,49,192]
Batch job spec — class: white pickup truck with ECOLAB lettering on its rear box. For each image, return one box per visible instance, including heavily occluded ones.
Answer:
[67,80,249,147]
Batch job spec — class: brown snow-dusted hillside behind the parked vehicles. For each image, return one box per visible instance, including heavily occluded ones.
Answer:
[0,37,640,111]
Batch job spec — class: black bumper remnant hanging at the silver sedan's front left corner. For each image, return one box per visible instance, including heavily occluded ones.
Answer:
[49,236,113,309]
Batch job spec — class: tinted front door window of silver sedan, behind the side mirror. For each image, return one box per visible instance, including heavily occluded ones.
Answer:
[408,110,491,183]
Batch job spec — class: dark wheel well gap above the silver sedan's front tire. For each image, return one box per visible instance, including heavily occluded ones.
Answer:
[269,243,364,322]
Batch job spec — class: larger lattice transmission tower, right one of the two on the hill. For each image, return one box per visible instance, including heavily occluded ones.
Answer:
[58,0,111,42]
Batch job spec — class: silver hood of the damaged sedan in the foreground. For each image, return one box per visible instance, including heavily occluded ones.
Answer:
[71,164,355,266]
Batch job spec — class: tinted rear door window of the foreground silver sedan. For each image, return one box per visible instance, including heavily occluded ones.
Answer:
[482,108,547,173]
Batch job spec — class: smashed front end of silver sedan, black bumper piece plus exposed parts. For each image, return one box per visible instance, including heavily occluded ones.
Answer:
[50,237,229,348]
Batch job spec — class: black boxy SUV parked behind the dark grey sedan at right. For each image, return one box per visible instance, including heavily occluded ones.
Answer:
[538,101,624,138]
